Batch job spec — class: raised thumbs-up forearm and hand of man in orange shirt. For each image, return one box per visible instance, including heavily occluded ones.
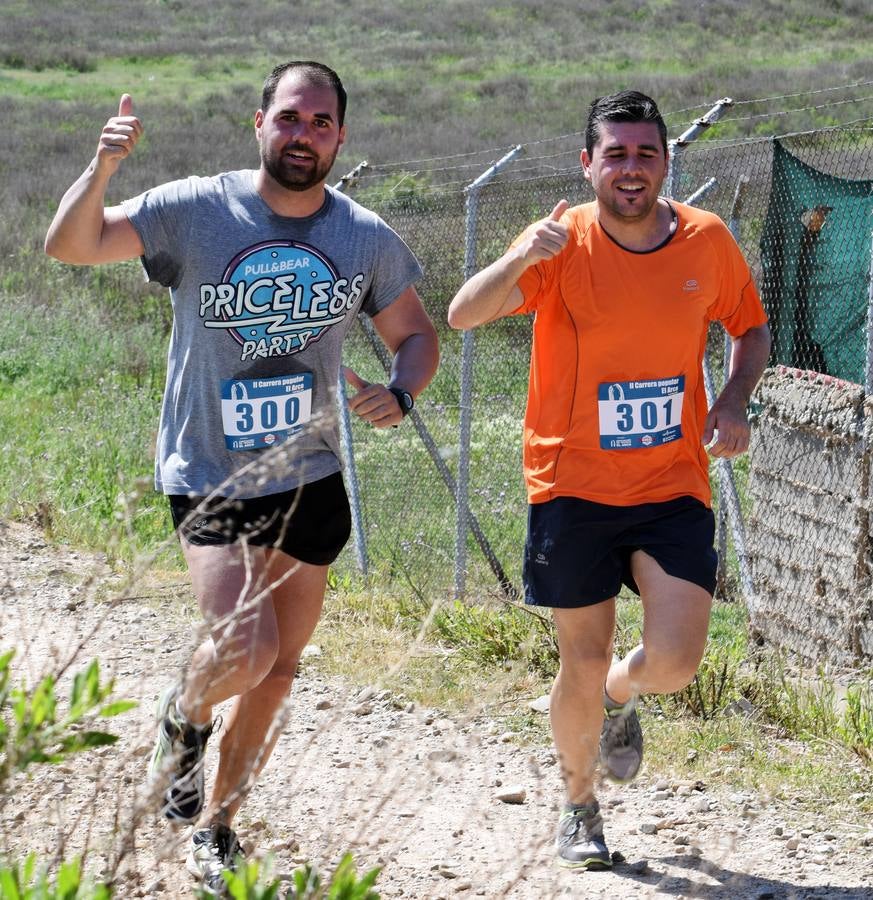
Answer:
[449,200,569,329]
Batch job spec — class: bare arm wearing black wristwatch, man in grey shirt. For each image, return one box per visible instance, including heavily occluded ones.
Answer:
[345,287,439,428]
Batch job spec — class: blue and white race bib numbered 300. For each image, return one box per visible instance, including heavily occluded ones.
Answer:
[221,372,312,450]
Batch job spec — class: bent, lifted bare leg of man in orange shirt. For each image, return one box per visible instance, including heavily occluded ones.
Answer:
[606,550,712,703]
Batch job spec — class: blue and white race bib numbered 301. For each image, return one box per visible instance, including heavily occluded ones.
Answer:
[597,375,685,450]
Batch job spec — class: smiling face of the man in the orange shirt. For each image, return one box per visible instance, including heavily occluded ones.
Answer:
[581,122,667,224]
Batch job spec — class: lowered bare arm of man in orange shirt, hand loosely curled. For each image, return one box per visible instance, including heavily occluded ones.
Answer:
[702,325,770,459]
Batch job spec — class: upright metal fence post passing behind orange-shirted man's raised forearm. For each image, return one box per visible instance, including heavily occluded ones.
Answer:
[455,144,522,599]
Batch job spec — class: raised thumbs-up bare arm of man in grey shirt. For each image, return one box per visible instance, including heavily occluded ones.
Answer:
[45,94,143,265]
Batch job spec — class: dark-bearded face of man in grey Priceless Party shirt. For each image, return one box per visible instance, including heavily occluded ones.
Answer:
[255,71,346,191]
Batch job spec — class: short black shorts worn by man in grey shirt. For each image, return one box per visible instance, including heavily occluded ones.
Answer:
[168,472,352,566]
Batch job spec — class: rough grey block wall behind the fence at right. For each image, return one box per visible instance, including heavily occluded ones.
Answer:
[747,367,873,666]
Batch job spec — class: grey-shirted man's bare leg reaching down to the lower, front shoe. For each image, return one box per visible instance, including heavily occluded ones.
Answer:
[200,550,327,825]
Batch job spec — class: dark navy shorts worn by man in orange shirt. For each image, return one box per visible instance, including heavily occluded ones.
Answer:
[524,497,718,609]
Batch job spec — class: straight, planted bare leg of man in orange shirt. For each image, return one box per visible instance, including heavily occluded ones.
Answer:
[550,599,615,803]
